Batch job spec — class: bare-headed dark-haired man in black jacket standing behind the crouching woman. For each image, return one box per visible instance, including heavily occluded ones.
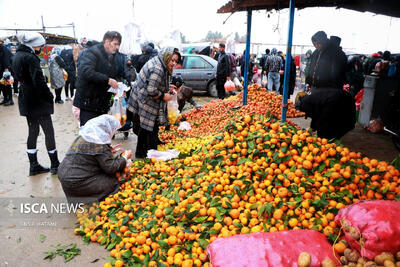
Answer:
[74,31,122,126]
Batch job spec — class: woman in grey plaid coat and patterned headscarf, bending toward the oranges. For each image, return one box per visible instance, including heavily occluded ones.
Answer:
[128,49,179,158]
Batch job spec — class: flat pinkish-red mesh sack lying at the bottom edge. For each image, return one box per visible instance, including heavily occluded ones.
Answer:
[207,230,339,267]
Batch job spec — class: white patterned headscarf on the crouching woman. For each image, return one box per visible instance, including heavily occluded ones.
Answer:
[79,115,121,145]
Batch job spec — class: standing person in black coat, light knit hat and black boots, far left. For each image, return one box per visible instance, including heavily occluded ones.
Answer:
[12,32,60,176]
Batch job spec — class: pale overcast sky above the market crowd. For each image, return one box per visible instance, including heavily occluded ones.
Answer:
[0,0,400,53]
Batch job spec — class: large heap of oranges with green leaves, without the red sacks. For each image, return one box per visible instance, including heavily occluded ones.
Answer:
[75,87,400,266]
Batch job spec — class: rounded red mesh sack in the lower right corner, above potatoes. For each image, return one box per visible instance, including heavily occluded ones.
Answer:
[335,200,400,259]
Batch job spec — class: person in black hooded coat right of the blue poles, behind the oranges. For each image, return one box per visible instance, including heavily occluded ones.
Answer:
[296,31,355,139]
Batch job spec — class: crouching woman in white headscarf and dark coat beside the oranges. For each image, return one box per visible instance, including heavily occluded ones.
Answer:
[58,115,132,202]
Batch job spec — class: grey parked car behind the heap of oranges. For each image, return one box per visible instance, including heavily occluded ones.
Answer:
[173,55,218,97]
